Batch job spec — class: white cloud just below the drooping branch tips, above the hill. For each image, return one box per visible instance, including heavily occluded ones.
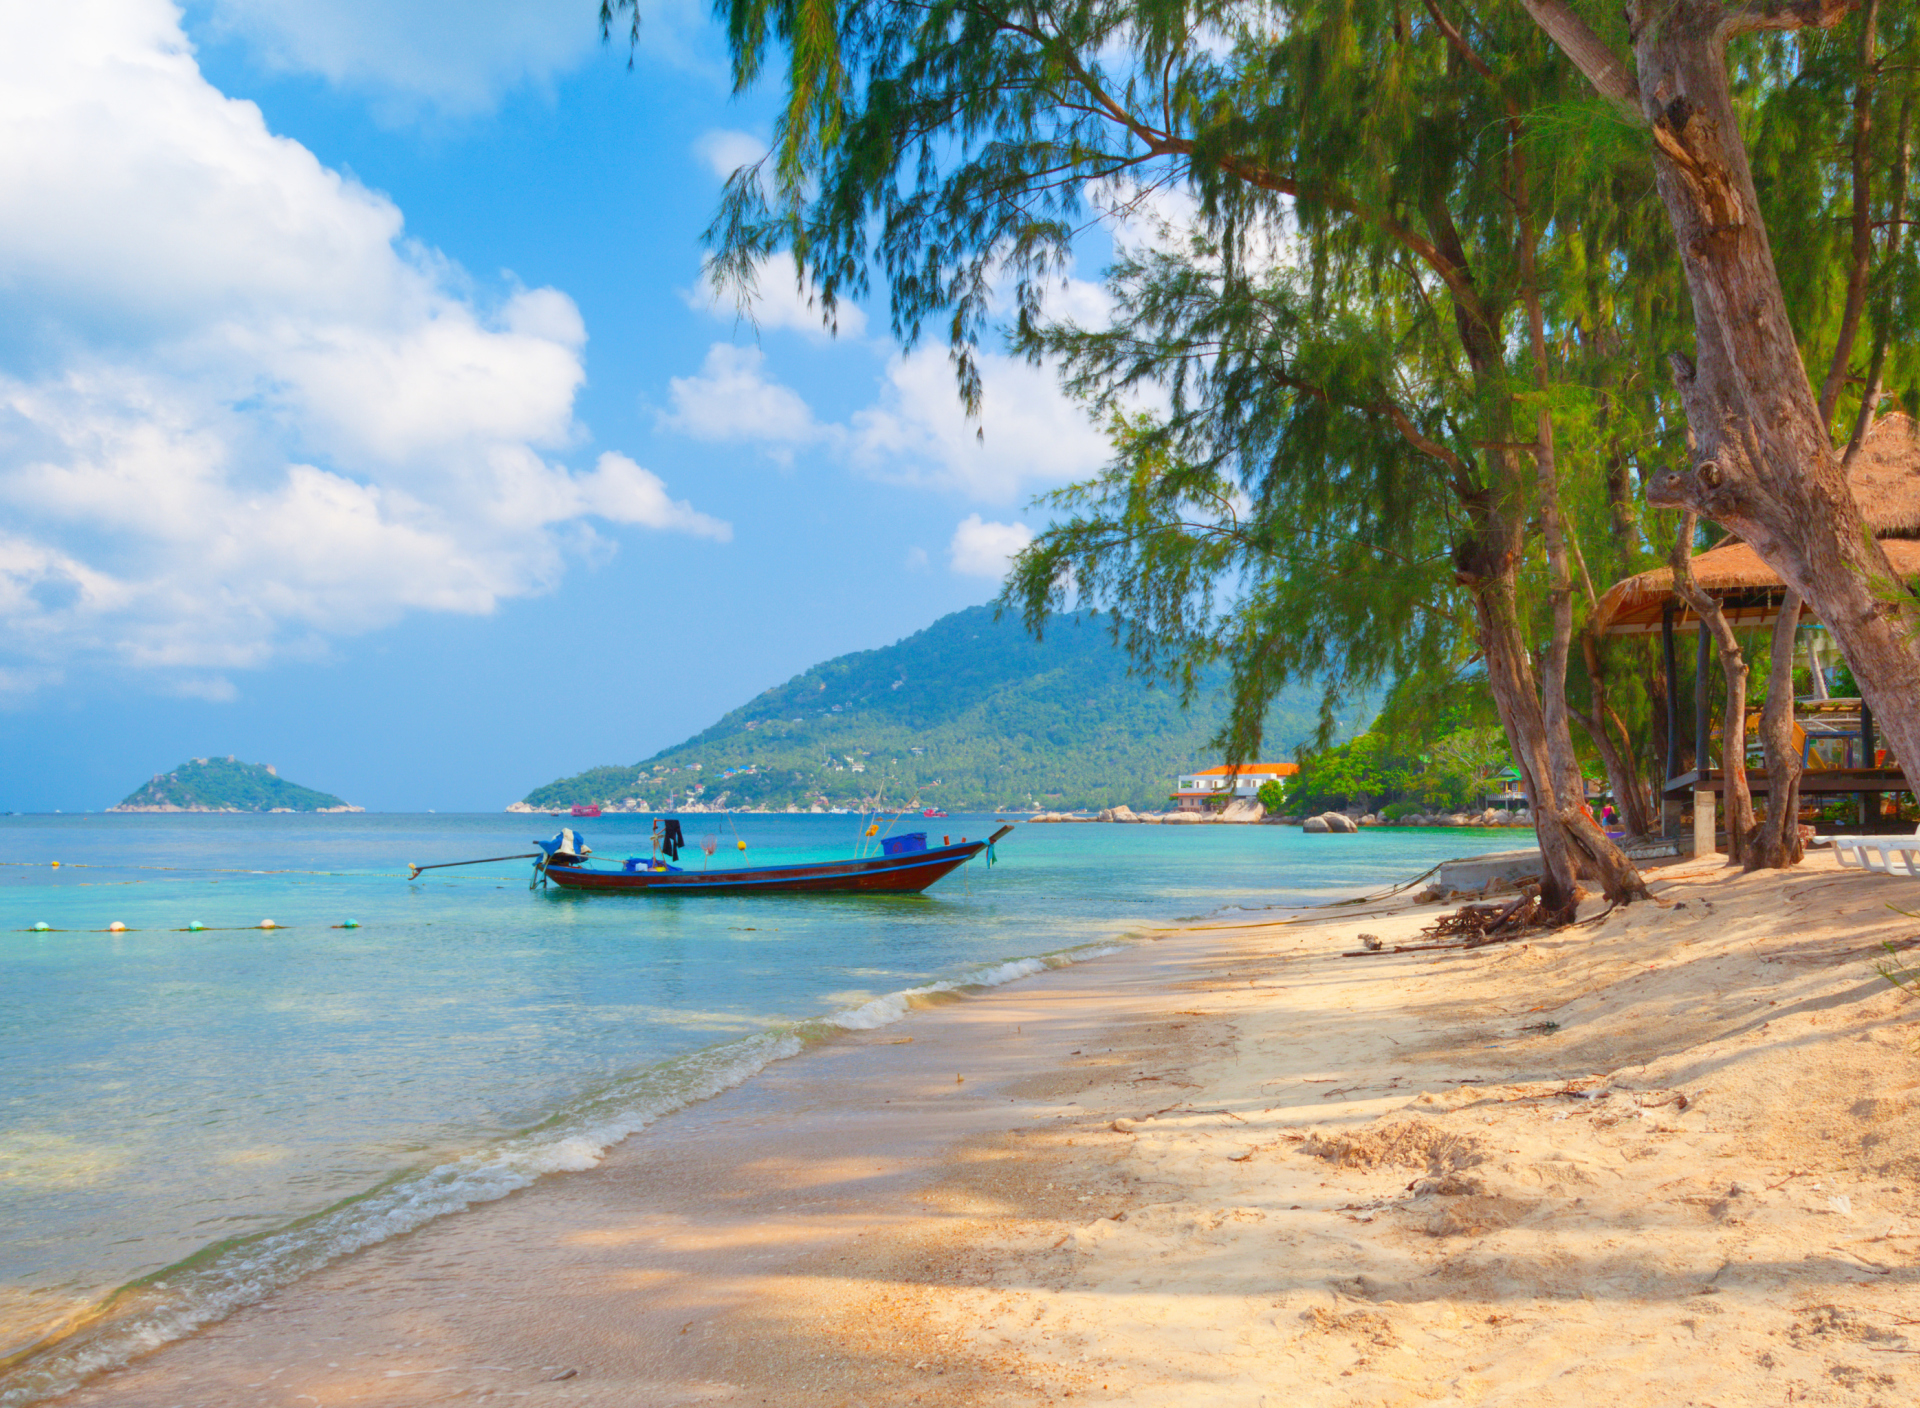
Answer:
[852,348,1112,503]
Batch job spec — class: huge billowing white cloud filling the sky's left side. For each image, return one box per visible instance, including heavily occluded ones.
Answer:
[0,0,728,697]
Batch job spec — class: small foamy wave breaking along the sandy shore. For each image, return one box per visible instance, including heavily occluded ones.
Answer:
[0,941,1129,1408]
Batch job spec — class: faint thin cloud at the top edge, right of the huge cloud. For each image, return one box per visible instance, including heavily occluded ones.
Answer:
[190,0,703,119]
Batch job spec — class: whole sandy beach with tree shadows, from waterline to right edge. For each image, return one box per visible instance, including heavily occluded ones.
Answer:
[60,855,1920,1408]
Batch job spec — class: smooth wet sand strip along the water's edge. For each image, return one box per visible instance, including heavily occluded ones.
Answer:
[40,906,1251,1404]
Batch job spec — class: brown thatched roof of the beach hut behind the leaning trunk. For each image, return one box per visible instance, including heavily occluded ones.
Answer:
[1594,415,1920,636]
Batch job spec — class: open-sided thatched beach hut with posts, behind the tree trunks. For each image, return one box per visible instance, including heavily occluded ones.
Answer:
[1594,415,1920,855]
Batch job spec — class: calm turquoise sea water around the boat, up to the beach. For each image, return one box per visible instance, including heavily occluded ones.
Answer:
[0,814,1530,1404]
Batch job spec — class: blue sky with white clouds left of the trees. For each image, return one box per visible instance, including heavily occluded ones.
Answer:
[0,0,1128,813]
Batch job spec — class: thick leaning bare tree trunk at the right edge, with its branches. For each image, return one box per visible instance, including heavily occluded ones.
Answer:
[1515,0,1920,829]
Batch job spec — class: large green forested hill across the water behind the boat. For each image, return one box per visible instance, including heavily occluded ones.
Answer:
[522,607,1371,811]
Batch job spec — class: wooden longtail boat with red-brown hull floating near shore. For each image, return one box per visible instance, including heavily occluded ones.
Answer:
[534,826,1014,895]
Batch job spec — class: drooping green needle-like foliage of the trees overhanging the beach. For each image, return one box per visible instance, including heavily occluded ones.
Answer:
[603,0,1916,833]
